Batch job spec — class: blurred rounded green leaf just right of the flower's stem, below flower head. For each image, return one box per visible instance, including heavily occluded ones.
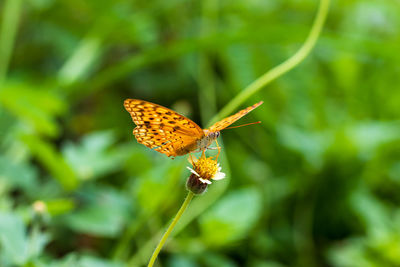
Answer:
[200,188,262,246]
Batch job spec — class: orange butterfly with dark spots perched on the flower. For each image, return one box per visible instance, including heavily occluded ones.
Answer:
[124,99,263,157]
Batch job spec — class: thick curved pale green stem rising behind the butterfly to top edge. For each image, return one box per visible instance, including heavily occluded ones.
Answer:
[211,0,330,123]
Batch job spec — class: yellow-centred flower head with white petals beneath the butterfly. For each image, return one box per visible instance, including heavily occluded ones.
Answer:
[186,156,225,194]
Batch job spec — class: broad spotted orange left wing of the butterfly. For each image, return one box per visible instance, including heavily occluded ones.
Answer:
[124,99,204,157]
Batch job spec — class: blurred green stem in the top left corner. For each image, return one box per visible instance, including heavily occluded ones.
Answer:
[0,0,21,84]
